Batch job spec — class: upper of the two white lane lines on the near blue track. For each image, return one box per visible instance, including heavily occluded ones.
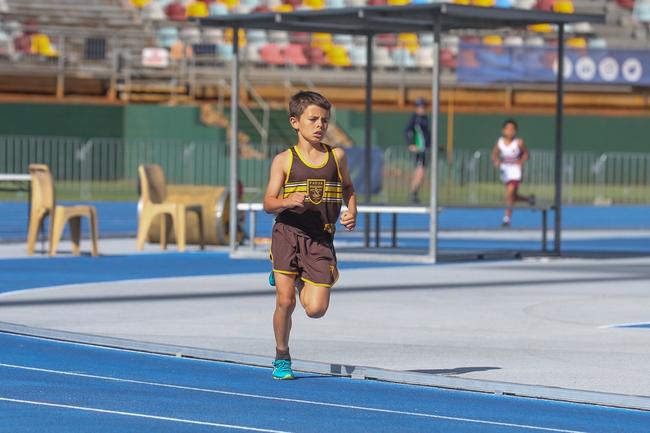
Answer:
[0,363,587,433]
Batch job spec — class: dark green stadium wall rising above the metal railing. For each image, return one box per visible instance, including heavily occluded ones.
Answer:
[0,103,650,152]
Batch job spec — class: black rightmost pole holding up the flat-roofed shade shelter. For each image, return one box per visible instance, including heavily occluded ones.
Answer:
[553,24,564,255]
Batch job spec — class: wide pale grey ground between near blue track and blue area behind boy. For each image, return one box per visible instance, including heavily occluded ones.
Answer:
[0,253,650,396]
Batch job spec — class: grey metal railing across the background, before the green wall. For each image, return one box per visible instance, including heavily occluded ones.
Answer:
[0,136,650,205]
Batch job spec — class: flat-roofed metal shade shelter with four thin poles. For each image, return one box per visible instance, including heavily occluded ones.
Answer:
[199,3,605,263]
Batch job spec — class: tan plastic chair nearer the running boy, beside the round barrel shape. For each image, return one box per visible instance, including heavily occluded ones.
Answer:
[136,164,205,252]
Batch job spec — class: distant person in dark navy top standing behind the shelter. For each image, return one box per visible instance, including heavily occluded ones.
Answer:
[404,98,431,203]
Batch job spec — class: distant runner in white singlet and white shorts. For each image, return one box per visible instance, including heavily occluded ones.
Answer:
[492,120,535,227]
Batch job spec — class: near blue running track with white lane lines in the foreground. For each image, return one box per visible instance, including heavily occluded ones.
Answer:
[0,333,650,433]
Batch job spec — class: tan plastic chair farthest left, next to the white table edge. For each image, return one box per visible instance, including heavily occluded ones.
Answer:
[27,164,99,256]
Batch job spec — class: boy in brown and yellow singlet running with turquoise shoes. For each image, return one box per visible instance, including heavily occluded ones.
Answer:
[264,92,357,380]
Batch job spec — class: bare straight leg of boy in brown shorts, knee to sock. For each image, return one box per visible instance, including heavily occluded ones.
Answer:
[273,272,296,355]
